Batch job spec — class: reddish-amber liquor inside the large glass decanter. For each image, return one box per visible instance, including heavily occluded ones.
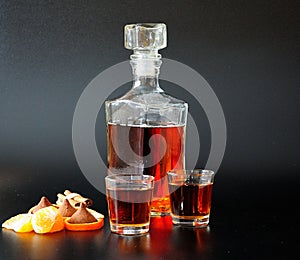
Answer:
[108,124,185,214]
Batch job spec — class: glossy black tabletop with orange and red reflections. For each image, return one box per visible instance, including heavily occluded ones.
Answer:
[0,168,300,260]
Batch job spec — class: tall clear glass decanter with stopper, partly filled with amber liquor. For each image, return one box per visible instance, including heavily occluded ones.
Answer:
[105,23,188,216]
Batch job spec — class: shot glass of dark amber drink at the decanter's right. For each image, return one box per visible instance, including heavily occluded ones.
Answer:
[168,169,214,227]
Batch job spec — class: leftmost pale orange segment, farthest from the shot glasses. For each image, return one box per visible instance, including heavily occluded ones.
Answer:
[2,214,33,232]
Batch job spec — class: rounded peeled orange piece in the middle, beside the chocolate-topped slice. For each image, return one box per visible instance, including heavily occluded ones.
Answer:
[31,206,64,234]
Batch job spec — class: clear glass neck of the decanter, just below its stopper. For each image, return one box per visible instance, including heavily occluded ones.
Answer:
[130,51,163,92]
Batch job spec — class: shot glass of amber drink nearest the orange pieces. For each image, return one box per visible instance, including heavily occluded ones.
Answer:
[105,173,154,235]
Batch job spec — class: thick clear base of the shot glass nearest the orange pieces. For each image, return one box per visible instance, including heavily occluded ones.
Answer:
[110,223,149,235]
